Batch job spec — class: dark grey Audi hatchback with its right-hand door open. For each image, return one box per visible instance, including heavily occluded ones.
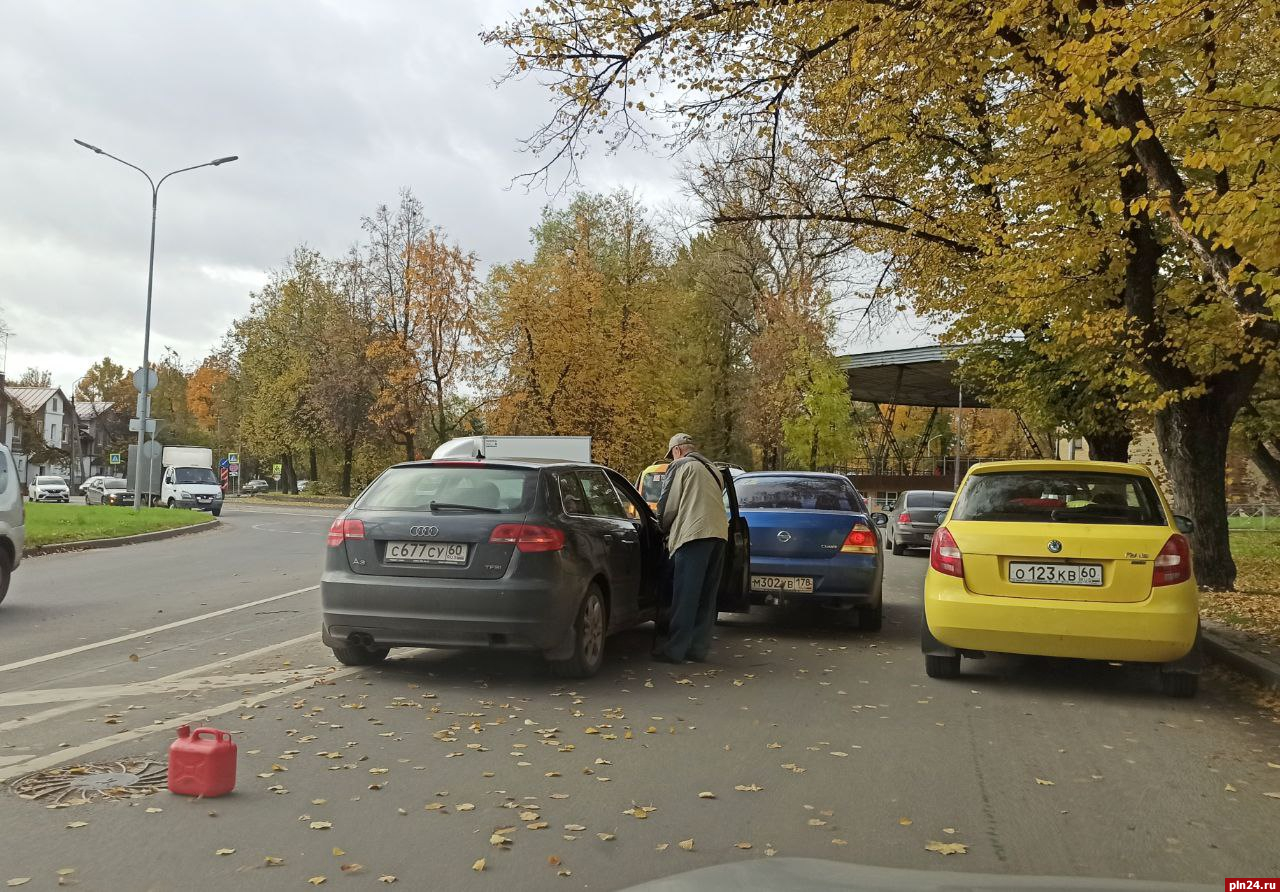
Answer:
[320,459,750,677]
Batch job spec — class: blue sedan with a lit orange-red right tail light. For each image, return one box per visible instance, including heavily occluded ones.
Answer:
[733,471,884,631]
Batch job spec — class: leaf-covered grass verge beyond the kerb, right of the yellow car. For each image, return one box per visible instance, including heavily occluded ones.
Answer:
[1201,530,1280,646]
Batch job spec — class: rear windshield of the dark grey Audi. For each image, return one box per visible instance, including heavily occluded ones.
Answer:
[357,465,538,514]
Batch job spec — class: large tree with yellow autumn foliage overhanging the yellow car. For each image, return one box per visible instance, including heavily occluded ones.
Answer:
[486,0,1280,587]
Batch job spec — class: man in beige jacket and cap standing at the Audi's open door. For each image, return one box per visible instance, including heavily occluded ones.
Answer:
[653,434,728,663]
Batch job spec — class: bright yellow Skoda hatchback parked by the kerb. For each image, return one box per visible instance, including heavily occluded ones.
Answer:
[920,461,1201,697]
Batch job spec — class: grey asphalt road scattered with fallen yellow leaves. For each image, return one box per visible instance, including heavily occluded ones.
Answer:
[0,506,1280,889]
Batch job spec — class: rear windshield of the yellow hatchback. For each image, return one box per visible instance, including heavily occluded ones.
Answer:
[951,471,1166,525]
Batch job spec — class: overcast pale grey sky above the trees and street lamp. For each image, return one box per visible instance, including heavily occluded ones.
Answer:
[0,0,931,389]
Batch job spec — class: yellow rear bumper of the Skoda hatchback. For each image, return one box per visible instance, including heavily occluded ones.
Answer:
[924,569,1199,663]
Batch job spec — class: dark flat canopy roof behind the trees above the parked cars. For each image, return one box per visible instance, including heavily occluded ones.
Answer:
[836,347,987,408]
